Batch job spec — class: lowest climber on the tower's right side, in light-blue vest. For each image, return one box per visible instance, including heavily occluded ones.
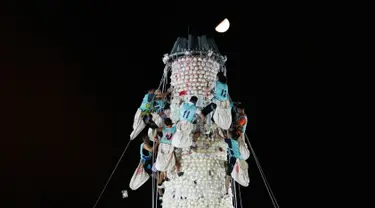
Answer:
[224,129,243,194]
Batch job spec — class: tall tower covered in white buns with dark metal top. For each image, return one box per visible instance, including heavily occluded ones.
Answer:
[162,35,233,208]
